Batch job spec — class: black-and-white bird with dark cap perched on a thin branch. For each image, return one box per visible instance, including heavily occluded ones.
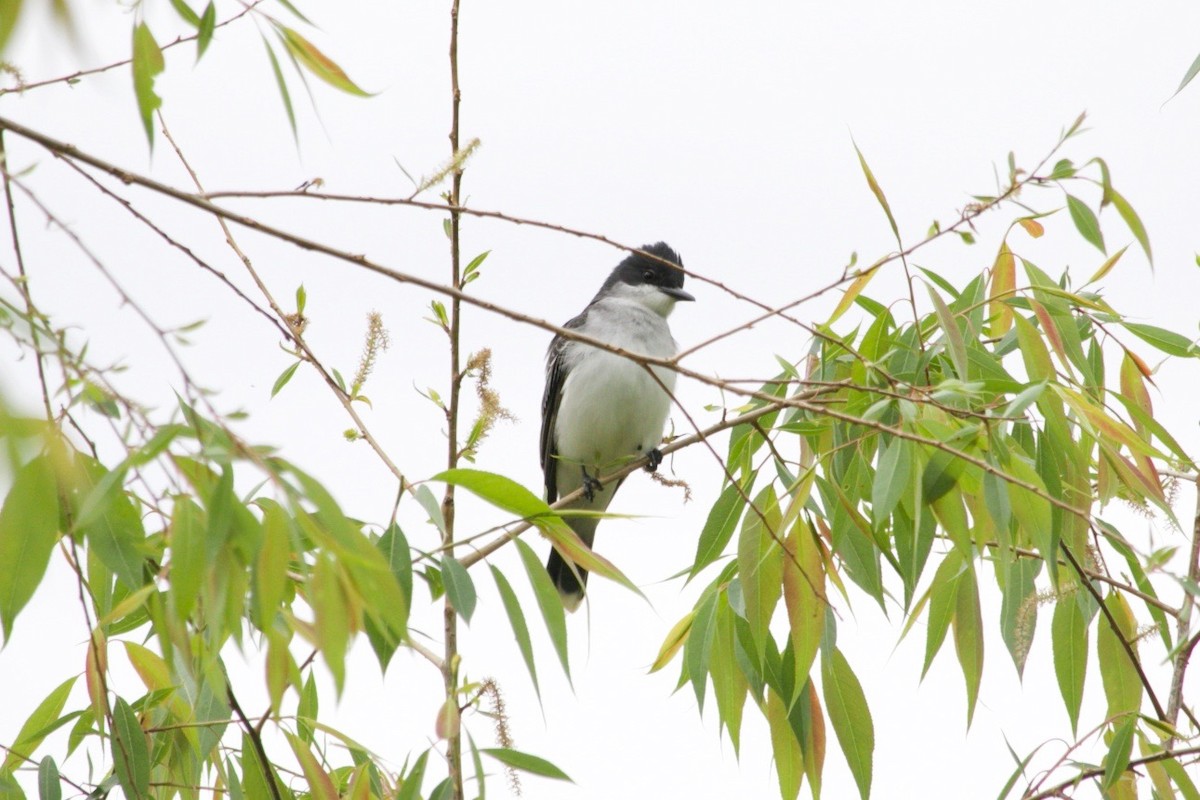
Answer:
[541,241,695,612]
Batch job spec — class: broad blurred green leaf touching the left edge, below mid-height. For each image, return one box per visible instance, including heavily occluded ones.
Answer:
[0,455,59,643]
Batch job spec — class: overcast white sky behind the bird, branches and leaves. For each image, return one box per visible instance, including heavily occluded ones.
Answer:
[0,0,1200,799]
